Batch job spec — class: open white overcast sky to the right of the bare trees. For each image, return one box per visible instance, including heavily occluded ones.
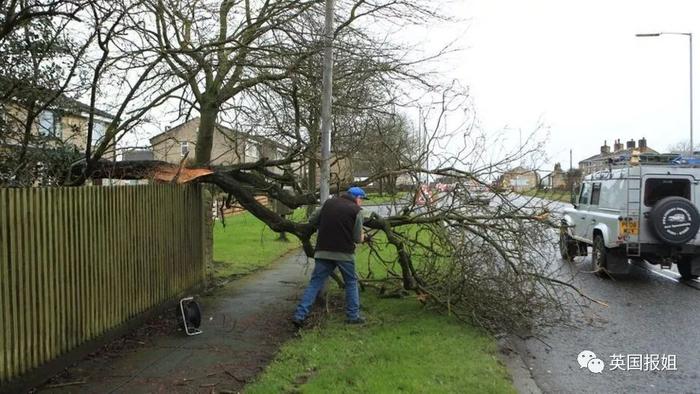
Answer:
[428,0,700,168]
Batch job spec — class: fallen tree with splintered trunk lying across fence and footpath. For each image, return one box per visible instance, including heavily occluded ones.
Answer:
[74,115,587,332]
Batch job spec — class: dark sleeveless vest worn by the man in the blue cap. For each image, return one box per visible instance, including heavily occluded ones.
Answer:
[316,194,361,253]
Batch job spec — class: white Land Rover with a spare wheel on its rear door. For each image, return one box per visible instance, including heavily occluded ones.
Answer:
[559,155,700,279]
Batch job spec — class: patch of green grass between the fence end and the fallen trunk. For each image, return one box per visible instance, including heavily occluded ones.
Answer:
[212,212,300,278]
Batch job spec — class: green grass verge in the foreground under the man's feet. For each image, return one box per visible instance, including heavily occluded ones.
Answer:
[245,229,515,393]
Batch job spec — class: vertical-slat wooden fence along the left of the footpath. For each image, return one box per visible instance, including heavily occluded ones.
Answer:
[0,185,208,383]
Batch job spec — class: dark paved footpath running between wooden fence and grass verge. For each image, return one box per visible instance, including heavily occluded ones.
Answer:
[40,252,307,394]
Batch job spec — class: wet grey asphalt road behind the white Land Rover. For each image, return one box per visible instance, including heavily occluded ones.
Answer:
[517,199,700,393]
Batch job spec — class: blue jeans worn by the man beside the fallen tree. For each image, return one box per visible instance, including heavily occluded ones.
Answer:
[294,259,360,320]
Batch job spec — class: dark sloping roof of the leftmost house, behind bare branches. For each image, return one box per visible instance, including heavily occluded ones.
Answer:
[0,77,115,119]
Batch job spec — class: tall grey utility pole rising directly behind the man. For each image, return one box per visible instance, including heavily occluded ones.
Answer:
[321,0,334,204]
